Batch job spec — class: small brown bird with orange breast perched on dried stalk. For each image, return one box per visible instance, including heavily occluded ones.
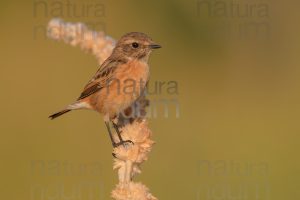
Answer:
[49,32,161,147]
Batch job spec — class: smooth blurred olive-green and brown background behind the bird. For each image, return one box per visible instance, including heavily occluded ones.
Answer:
[0,0,300,200]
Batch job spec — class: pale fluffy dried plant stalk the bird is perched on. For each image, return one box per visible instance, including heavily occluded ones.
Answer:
[48,19,157,200]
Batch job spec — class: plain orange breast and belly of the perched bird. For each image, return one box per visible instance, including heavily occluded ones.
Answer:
[90,60,149,117]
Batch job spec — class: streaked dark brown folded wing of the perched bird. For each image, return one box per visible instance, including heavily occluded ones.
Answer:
[77,59,122,100]
